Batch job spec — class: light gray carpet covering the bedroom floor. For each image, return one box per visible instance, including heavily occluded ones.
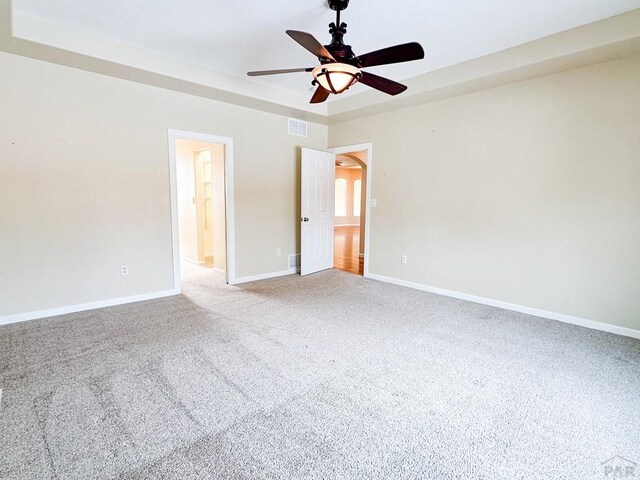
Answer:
[0,268,640,480]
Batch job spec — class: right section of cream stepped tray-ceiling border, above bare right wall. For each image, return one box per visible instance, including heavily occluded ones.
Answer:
[328,9,640,124]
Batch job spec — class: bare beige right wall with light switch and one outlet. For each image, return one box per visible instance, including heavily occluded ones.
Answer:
[329,52,640,329]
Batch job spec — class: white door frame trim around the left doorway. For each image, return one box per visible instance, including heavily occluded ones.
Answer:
[167,128,236,293]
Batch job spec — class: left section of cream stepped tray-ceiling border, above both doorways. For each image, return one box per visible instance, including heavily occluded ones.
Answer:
[0,0,328,124]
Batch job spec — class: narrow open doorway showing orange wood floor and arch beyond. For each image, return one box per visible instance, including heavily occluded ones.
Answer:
[333,150,367,275]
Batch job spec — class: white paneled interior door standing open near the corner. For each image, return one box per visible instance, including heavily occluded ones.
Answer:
[300,148,336,275]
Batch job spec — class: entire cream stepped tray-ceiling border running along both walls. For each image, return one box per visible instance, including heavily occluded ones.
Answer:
[0,0,640,125]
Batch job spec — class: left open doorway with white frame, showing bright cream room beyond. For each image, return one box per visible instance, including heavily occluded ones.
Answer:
[169,130,235,290]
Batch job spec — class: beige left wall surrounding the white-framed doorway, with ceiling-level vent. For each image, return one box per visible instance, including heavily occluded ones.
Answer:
[0,53,327,316]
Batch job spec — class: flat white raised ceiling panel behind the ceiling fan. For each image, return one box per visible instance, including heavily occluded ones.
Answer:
[14,0,640,99]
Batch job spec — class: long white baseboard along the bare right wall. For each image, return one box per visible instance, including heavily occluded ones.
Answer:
[366,273,640,339]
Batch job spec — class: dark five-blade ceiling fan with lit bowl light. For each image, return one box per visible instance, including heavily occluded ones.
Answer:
[247,0,424,103]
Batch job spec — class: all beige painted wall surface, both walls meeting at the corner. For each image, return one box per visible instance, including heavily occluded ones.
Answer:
[0,46,640,329]
